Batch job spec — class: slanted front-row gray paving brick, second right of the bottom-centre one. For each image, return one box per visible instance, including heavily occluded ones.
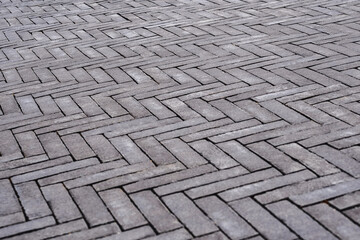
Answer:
[230,198,297,239]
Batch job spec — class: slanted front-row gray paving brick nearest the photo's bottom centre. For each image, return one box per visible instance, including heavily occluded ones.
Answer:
[163,193,218,236]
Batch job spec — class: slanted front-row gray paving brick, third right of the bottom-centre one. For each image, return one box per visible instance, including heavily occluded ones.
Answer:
[267,201,337,239]
